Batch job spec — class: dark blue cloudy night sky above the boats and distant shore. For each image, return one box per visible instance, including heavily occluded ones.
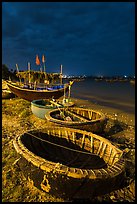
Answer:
[2,2,135,76]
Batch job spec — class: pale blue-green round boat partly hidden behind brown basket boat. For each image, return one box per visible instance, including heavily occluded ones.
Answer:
[31,99,74,119]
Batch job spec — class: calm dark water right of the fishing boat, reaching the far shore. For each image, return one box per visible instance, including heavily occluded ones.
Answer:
[71,79,135,113]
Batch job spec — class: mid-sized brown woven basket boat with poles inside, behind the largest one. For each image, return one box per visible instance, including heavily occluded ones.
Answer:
[45,107,107,133]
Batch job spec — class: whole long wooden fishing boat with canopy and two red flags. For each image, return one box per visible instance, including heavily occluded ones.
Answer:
[6,55,73,102]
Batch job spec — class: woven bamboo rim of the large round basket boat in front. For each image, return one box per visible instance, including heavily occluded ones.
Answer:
[13,126,125,179]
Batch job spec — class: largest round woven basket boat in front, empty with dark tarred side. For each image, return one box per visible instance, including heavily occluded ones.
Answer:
[13,126,125,200]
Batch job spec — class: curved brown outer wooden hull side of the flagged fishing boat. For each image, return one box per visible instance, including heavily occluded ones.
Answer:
[7,81,69,102]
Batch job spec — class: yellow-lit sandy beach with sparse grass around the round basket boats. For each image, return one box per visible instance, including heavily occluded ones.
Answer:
[2,97,135,202]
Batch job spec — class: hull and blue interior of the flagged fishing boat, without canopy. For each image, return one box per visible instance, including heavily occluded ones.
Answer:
[6,81,70,101]
